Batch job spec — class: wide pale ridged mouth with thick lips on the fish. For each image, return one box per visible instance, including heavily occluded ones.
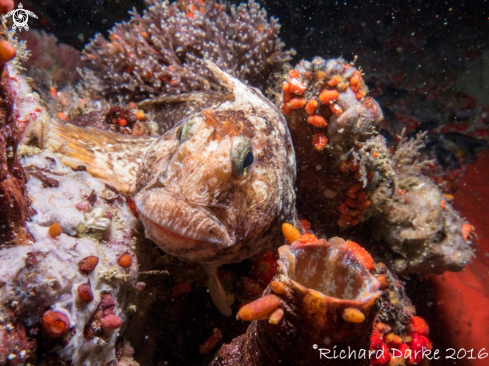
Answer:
[135,188,234,249]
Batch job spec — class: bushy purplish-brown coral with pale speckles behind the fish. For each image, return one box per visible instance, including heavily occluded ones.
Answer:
[84,0,293,101]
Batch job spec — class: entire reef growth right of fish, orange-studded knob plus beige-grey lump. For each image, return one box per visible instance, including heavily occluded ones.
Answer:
[279,57,472,273]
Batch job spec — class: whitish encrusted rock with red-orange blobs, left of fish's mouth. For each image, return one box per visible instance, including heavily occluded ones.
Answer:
[0,152,142,365]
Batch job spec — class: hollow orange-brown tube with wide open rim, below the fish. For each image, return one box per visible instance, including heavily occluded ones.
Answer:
[210,238,380,366]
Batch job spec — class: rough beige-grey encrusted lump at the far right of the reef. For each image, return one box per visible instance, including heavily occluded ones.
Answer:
[371,167,473,274]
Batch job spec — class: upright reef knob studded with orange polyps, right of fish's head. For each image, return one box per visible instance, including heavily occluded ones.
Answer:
[278,57,383,236]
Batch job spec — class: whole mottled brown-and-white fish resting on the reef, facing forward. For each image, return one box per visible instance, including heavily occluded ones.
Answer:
[47,62,296,315]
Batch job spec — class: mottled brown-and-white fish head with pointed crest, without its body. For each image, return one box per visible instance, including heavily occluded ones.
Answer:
[135,63,295,265]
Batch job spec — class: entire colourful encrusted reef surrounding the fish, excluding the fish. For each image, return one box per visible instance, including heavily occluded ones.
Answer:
[0,0,480,366]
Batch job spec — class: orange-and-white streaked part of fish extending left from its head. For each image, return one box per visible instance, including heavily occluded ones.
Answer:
[43,120,156,193]
